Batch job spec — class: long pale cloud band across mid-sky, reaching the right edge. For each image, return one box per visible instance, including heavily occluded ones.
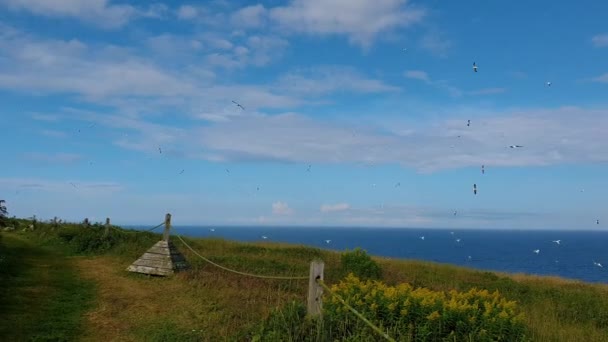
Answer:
[186,107,608,172]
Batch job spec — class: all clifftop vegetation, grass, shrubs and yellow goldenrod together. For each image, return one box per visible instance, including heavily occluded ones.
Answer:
[0,219,608,341]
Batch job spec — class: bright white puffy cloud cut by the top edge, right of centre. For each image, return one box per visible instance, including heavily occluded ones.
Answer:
[269,0,425,47]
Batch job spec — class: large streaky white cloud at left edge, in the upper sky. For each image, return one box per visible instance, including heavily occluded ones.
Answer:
[0,26,299,115]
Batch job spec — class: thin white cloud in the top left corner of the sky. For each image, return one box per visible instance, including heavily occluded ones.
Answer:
[2,0,166,29]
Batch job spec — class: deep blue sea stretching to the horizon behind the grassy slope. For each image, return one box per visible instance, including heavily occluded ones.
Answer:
[134,226,608,283]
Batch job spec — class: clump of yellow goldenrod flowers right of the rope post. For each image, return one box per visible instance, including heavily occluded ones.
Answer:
[323,273,526,341]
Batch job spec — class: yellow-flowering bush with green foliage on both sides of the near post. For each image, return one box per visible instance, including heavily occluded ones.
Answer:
[253,274,529,342]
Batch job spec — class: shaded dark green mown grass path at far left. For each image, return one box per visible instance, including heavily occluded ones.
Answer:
[0,233,95,341]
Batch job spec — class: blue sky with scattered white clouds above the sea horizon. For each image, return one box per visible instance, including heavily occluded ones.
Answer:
[0,0,608,230]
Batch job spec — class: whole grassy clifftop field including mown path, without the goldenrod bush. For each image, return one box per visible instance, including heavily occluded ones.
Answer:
[0,219,608,341]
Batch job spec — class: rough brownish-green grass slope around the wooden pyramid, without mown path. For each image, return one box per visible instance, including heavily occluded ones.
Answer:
[0,220,608,341]
